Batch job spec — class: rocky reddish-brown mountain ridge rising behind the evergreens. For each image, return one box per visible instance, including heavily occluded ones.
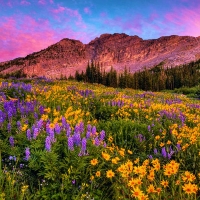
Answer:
[0,33,200,78]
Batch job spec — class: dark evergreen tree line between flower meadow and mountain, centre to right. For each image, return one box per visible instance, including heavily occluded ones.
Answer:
[75,60,200,91]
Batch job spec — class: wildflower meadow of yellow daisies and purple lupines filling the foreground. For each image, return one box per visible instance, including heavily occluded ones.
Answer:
[0,79,200,200]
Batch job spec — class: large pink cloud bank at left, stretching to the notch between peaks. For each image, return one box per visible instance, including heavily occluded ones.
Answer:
[0,16,92,62]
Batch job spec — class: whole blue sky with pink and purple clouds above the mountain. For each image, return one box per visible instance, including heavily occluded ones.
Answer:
[0,0,200,62]
